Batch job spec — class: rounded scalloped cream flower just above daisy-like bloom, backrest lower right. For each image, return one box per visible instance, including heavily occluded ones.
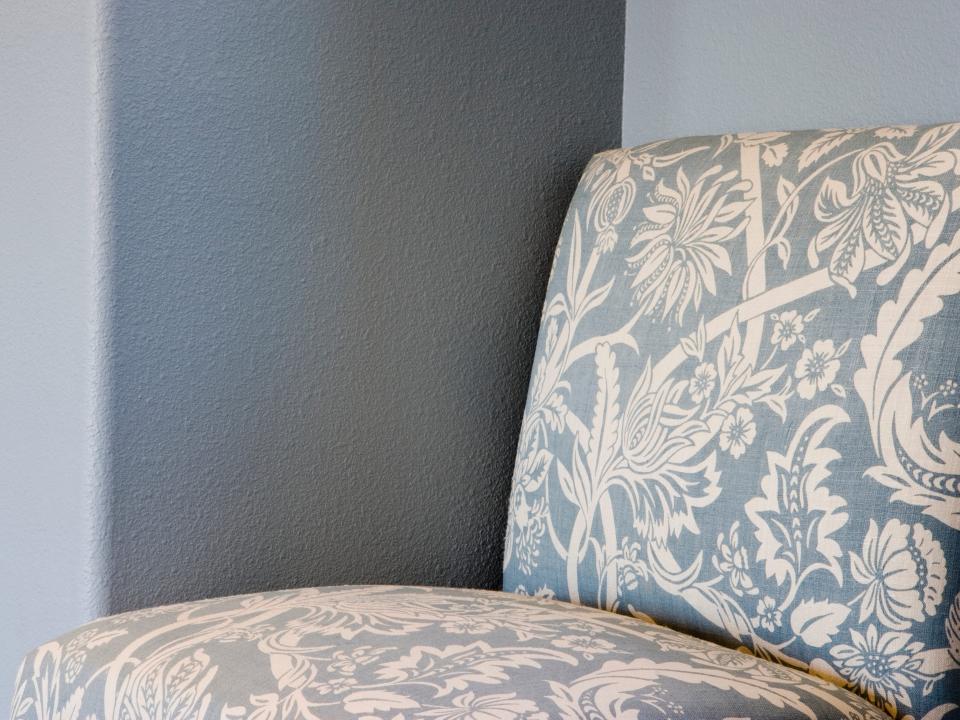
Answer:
[850,518,947,630]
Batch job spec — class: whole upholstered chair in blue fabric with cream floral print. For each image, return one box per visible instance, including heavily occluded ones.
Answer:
[13,124,960,720]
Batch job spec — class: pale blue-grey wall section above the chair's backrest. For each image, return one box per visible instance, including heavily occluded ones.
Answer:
[623,0,960,145]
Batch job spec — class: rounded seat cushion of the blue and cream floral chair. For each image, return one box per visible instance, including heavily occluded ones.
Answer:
[13,587,886,720]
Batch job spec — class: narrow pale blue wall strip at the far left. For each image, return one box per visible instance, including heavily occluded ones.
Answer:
[0,0,95,713]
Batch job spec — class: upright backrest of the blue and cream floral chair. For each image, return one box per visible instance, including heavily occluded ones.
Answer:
[504,124,960,718]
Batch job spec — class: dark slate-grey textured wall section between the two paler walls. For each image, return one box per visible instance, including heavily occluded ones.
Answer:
[99,0,624,611]
